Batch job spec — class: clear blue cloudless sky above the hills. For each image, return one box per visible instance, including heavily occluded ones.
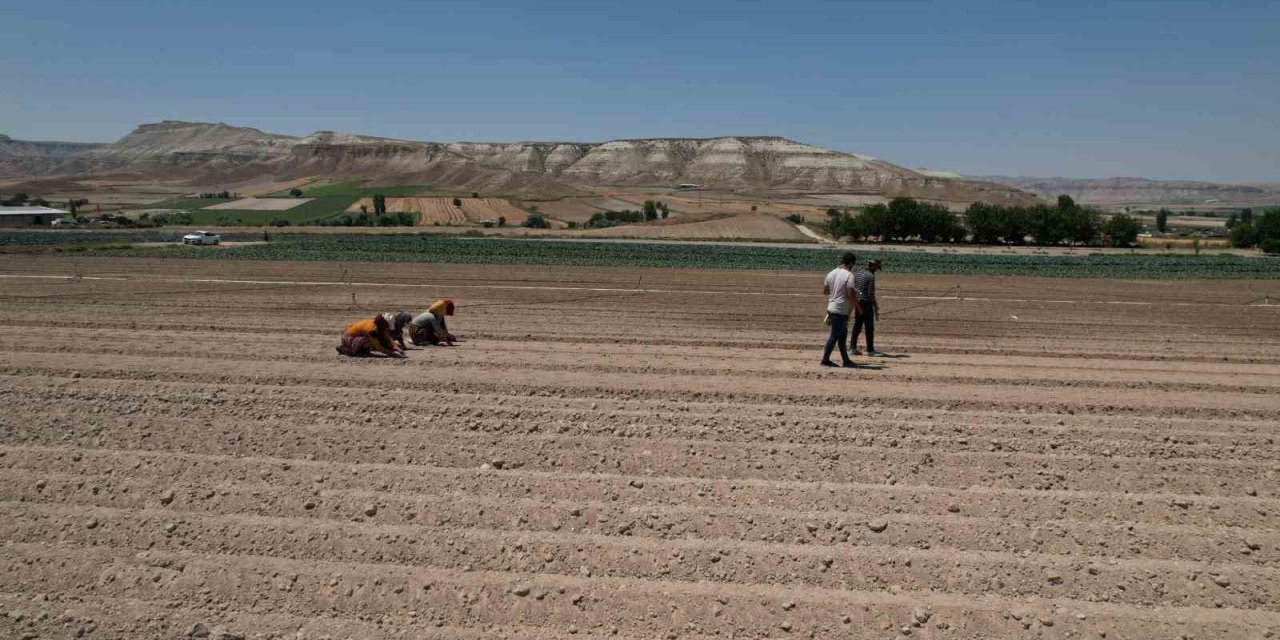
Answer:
[0,0,1280,182]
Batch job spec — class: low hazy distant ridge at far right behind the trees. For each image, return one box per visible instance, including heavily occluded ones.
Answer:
[974,175,1280,207]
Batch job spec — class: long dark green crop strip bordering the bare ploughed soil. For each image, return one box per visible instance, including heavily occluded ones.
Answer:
[77,233,1280,280]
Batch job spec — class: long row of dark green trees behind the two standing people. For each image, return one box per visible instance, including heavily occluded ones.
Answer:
[827,196,1142,247]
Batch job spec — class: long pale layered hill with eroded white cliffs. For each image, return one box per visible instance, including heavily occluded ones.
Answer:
[0,120,1033,202]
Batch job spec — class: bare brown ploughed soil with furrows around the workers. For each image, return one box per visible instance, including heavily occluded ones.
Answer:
[0,256,1280,639]
